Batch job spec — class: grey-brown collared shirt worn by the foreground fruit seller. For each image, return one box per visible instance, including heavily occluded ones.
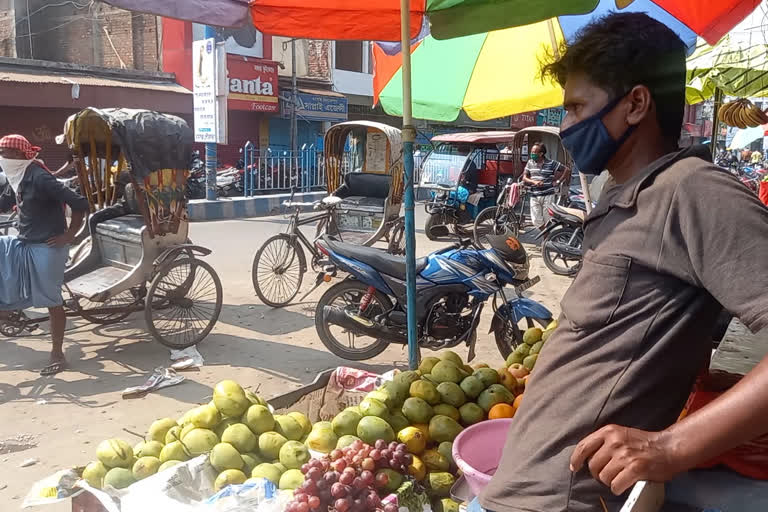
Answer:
[480,146,768,512]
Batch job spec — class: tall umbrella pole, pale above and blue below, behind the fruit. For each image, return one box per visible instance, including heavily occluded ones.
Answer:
[400,0,421,370]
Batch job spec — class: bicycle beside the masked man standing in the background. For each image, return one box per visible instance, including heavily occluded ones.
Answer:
[473,178,528,249]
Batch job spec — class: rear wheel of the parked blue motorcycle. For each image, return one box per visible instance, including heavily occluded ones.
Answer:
[315,279,392,361]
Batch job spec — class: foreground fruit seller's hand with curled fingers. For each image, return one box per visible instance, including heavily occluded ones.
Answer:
[571,425,686,496]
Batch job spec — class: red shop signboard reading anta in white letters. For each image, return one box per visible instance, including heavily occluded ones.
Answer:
[227,54,280,112]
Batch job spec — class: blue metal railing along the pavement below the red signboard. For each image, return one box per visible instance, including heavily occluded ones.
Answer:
[243,142,352,197]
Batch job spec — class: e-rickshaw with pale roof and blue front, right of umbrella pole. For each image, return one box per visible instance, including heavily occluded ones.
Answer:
[420,131,516,240]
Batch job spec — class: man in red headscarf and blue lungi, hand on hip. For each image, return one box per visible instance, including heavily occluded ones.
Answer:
[0,135,88,375]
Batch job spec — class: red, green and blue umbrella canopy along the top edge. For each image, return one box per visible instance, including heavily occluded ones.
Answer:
[244,0,760,44]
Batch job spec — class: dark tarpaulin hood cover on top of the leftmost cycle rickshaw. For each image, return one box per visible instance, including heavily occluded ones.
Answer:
[65,108,193,179]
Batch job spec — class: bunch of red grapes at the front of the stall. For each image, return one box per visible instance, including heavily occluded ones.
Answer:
[286,440,413,512]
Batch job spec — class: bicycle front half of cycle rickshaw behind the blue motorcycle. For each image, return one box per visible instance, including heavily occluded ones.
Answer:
[251,194,341,308]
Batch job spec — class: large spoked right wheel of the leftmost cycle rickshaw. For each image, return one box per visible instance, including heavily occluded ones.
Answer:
[144,258,222,349]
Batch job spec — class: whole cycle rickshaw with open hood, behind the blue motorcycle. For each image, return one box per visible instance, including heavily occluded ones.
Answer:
[251,121,405,307]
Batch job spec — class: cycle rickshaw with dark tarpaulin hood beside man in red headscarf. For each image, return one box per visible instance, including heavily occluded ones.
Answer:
[0,108,222,349]
